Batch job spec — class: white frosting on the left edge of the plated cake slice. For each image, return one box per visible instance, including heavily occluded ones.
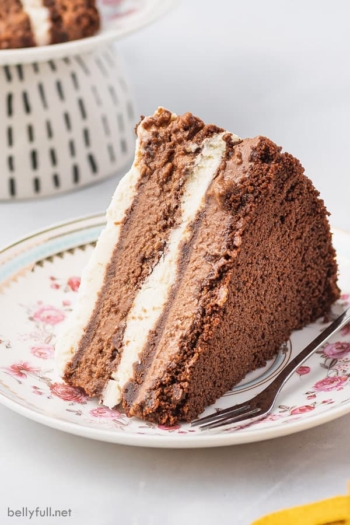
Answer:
[55,140,141,376]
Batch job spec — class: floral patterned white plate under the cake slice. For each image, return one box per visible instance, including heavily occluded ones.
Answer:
[0,215,350,448]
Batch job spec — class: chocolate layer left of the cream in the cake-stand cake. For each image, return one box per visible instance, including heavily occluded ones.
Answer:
[0,0,36,49]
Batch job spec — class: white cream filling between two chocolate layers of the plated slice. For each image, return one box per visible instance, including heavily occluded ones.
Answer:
[102,133,227,408]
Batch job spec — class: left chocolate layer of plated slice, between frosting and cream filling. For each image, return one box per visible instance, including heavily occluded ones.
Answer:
[65,111,221,395]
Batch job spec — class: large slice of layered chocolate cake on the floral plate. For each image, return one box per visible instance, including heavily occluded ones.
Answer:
[57,108,339,424]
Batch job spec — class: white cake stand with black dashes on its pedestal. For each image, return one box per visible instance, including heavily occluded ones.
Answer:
[0,0,174,200]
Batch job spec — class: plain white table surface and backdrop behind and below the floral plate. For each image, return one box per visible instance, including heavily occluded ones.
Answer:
[0,0,350,525]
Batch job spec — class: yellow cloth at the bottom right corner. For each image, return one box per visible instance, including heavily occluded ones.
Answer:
[252,495,350,525]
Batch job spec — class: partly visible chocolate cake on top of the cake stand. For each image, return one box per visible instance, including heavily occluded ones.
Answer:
[0,0,100,49]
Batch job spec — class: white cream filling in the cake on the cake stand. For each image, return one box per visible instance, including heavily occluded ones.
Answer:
[21,0,52,46]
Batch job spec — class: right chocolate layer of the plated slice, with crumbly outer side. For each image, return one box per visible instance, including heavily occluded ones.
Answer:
[124,138,339,425]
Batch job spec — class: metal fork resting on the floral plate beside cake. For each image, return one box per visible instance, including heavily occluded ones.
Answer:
[191,308,350,430]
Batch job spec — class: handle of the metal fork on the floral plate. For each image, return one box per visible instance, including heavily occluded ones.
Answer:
[265,308,350,402]
